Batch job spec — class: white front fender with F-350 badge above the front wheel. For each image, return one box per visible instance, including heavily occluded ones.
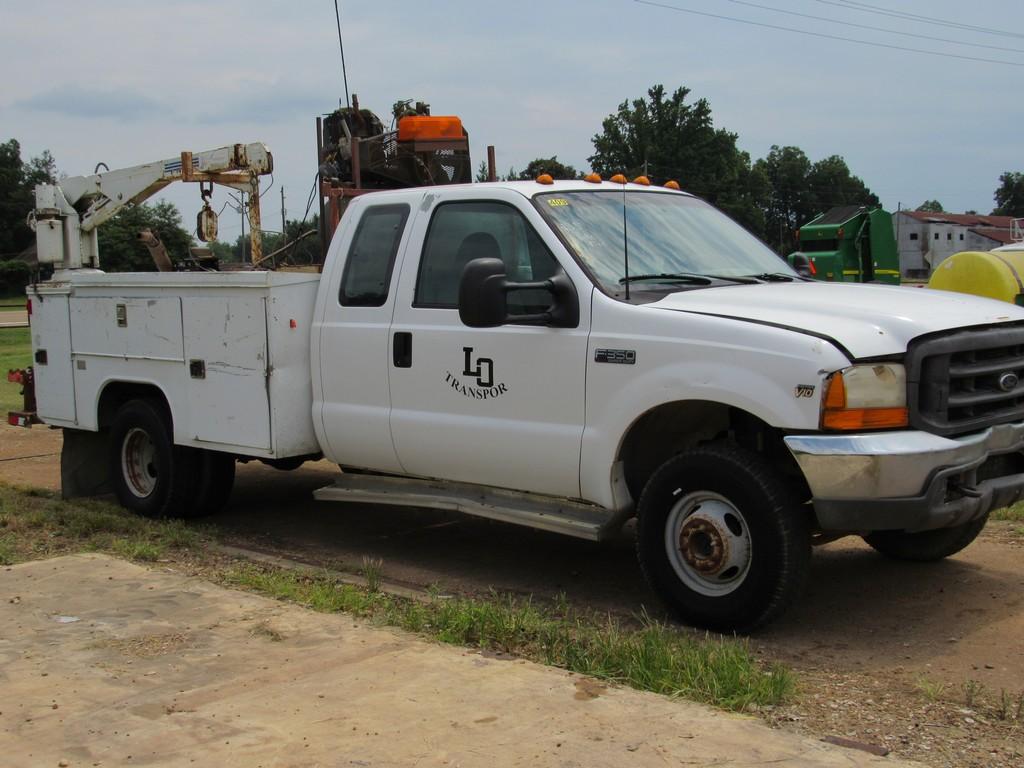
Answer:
[580,302,850,507]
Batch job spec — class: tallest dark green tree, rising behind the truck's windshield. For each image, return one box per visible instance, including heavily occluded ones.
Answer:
[588,85,766,234]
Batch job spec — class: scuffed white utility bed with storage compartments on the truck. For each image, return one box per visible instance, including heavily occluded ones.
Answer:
[29,271,319,459]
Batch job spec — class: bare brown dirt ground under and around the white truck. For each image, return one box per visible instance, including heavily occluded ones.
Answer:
[0,427,1024,767]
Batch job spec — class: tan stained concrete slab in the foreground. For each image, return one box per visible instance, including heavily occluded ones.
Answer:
[0,555,905,768]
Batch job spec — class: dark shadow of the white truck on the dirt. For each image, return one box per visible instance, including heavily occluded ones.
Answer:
[222,465,1024,668]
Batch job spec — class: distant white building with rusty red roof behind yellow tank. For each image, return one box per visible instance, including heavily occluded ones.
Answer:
[893,211,1013,280]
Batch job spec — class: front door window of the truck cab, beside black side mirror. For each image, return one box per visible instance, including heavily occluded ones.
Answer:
[413,203,558,314]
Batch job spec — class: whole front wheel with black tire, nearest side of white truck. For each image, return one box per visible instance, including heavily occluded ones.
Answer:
[637,443,811,632]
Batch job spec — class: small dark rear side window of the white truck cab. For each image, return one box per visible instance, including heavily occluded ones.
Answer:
[338,205,409,306]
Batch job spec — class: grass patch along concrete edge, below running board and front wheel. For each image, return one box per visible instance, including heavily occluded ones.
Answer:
[221,563,796,711]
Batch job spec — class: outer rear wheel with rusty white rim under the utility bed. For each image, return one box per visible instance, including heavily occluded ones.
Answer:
[110,399,198,517]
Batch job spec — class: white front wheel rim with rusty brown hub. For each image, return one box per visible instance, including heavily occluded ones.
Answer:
[665,490,753,597]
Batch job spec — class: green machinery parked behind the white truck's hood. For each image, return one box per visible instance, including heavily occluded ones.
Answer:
[786,206,900,286]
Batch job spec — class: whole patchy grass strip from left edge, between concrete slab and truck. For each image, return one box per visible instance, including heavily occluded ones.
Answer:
[0,483,796,712]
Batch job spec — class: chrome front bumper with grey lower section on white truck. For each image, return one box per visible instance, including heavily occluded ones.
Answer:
[784,422,1024,530]
